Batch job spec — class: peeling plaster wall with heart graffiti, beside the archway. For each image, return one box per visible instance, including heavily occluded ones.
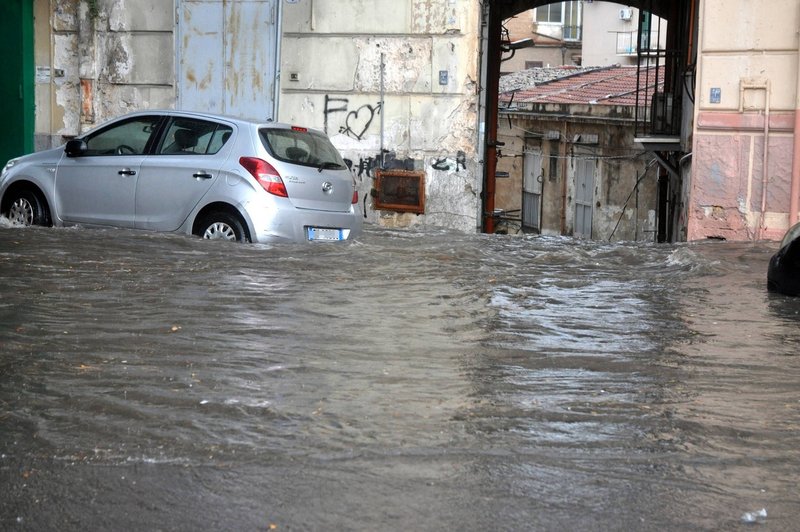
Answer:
[279,0,482,231]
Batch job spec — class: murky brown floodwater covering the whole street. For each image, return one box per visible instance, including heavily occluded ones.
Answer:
[0,223,800,531]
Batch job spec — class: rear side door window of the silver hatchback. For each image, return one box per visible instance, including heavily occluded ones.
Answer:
[158,117,233,155]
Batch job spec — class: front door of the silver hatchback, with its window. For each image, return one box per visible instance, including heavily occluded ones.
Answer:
[55,115,161,227]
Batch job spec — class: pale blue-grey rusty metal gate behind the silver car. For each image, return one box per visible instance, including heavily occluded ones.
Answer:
[178,0,280,120]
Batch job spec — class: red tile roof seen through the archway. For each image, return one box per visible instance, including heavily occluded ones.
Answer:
[500,66,664,106]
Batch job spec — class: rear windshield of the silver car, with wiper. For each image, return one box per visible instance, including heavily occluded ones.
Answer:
[259,127,347,169]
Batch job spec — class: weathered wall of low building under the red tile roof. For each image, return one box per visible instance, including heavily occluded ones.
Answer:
[495,106,657,241]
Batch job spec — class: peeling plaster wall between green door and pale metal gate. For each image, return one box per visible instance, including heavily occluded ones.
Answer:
[34,0,175,145]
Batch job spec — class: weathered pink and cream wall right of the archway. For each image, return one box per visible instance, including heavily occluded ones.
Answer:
[687,0,800,240]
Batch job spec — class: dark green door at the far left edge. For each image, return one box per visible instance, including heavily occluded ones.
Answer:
[0,0,34,166]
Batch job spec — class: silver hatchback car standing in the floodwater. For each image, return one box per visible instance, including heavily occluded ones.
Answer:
[0,111,363,242]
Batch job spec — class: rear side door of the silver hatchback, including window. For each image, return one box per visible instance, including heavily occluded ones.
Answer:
[135,116,233,231]
